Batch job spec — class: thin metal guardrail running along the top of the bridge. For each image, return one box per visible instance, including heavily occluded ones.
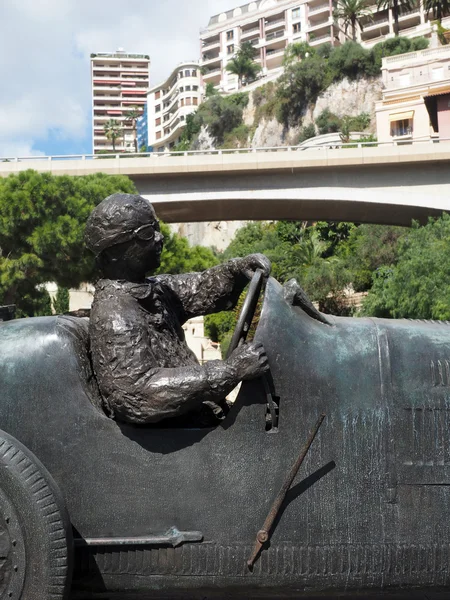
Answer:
[0,137,450,163]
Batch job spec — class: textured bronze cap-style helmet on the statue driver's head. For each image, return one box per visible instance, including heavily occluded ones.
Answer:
[84,194,158,256]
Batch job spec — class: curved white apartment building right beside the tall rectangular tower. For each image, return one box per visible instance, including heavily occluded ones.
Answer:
[147,62,203,152]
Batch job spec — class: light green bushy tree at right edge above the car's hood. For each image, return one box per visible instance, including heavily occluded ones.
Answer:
[363,214,450,320]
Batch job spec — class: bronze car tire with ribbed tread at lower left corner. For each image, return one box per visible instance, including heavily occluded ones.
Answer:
[0,430,73,600]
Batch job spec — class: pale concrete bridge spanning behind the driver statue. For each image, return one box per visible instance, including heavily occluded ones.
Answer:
[0,140,450,225]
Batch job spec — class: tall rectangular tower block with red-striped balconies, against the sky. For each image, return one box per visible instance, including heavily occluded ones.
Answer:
[91,49,150,154]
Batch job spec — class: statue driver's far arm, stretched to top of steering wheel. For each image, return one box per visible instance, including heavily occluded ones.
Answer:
[157,254,271,322]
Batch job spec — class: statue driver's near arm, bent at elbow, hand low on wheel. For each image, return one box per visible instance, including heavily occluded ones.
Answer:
[90,298,268,424]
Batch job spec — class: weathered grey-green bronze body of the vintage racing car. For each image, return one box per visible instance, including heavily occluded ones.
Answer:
[0,279,450,598]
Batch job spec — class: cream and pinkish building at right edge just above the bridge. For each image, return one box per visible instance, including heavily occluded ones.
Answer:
[376,46,450,143]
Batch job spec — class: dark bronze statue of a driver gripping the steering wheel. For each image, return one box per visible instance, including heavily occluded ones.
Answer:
[85,194,270,424]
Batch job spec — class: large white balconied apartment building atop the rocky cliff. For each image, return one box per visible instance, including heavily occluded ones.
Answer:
[200,0,446,92]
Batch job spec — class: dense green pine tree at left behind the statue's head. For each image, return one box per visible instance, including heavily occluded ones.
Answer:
[0,170,136,316]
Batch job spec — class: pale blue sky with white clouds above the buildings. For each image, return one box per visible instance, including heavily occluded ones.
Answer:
[0,0,239,158]
